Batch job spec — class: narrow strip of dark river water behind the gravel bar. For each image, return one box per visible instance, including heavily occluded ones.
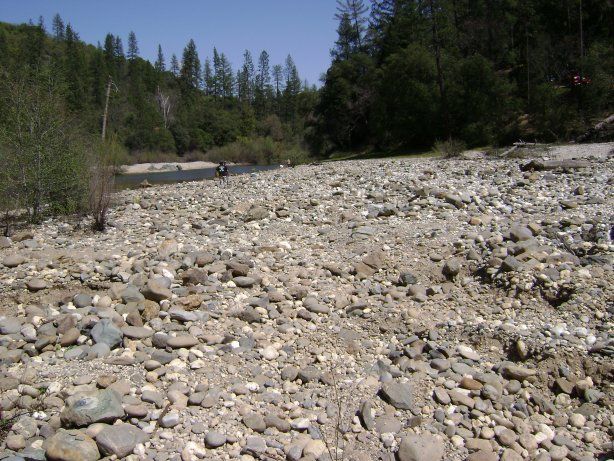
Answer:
[115,165,279,189]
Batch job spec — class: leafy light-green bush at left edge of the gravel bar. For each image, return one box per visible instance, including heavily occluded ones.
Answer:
[0,69,88,221]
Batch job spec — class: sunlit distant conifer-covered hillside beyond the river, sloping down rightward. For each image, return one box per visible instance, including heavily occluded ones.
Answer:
[0,15,317,163]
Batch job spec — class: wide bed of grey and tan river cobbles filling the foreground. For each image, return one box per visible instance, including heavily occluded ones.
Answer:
[0,157,614,461]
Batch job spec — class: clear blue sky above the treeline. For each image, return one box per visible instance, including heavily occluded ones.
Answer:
[0,0,337,86]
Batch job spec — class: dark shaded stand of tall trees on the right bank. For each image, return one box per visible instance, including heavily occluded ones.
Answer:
[312,0,614,152]
